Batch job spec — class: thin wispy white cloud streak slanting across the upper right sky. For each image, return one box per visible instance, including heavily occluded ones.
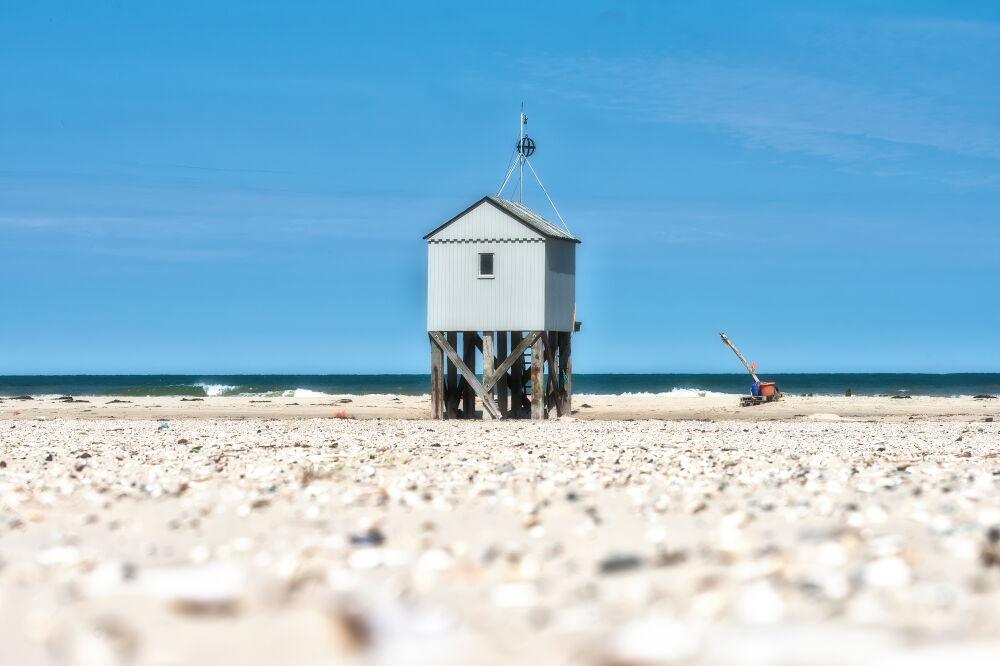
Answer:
[532,58,1000,160]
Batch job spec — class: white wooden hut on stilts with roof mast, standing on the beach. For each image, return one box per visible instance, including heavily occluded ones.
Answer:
[424,111,580,419]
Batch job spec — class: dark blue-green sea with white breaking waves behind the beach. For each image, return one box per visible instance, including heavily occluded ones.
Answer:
[0,373,1000,398]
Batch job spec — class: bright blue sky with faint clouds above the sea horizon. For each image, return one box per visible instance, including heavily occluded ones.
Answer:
[0,0,1000,374]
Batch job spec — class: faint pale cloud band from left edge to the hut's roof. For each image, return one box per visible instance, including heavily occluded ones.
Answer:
[0,177,454,240]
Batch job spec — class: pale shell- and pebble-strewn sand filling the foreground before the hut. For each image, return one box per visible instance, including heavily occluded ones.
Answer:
[0,415,1000,666]
